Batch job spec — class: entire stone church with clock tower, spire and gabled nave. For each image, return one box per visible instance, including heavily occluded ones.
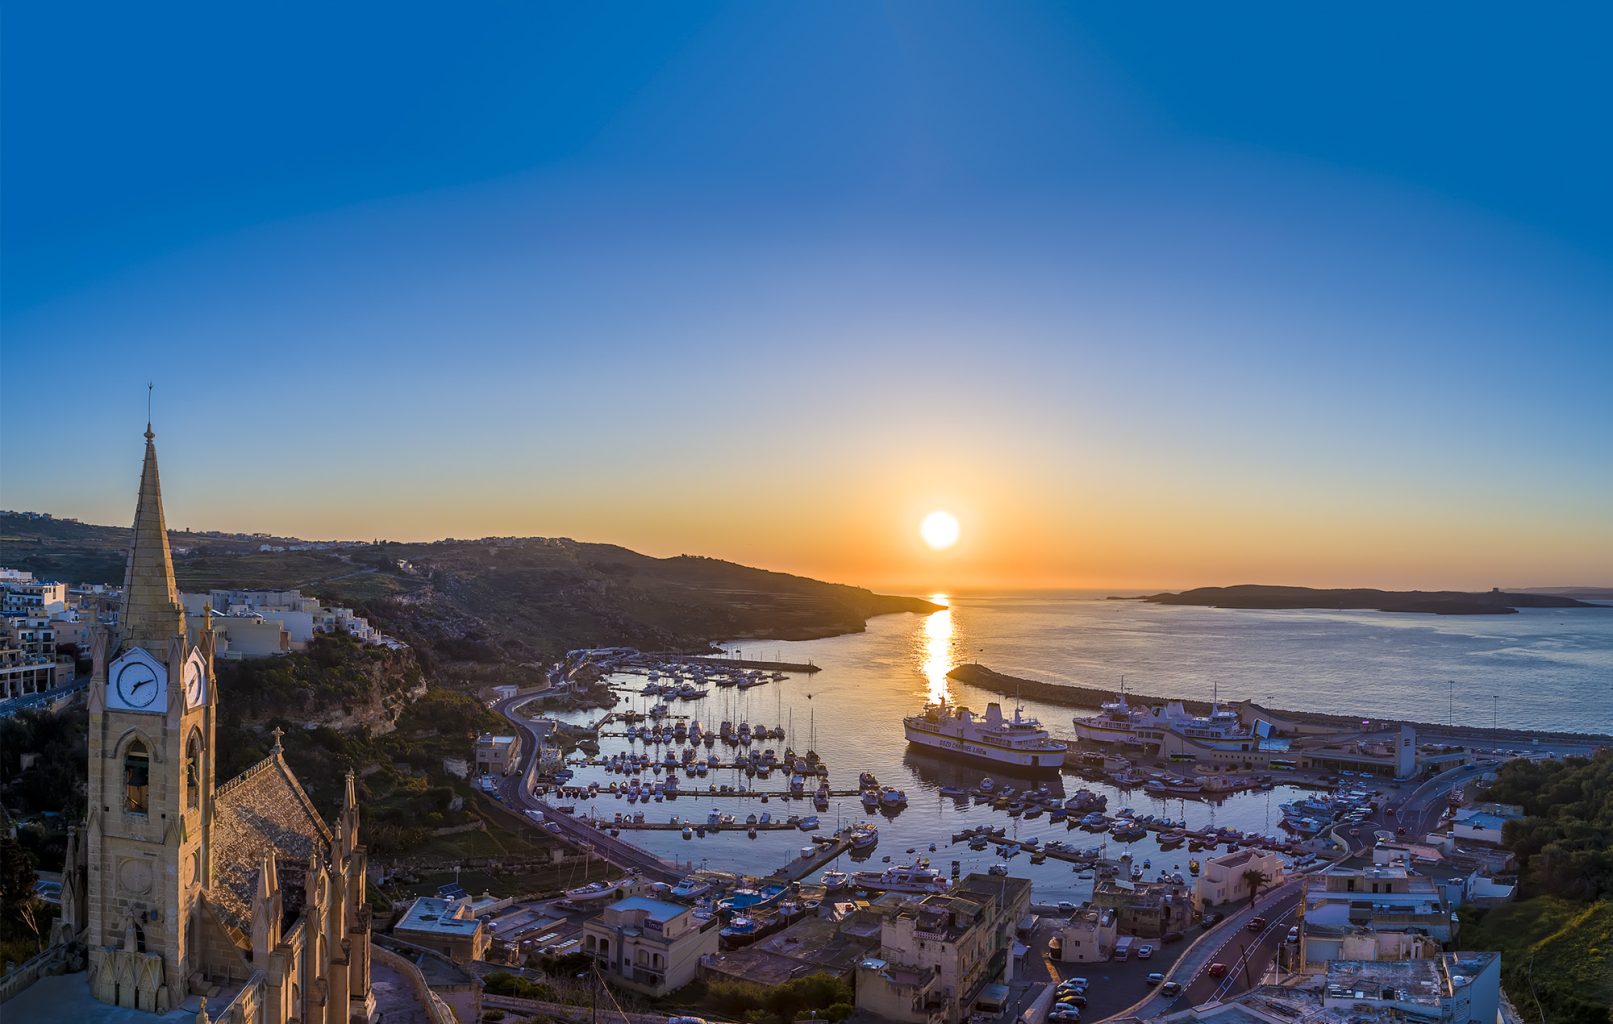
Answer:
[58,426,374,1024]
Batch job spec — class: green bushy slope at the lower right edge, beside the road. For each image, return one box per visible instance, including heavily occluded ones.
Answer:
[1461,750,1613,1024]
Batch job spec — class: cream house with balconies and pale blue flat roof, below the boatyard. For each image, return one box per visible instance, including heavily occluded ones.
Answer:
[582,897,719,997]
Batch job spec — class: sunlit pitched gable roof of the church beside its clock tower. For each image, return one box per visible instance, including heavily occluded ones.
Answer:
[208,750,332,942]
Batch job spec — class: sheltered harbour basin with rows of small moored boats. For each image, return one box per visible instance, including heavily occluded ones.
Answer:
[509,601,1606,901]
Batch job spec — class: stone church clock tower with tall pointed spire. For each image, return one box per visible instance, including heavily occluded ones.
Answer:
[84,424,216,1013]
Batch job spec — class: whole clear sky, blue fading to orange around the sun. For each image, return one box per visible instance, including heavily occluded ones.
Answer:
[0,3,1613,585]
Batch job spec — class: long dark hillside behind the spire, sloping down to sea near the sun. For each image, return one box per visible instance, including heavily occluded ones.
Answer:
[0,513,936,684]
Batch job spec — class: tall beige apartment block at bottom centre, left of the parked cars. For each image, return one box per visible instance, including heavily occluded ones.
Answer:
[857,874,1031,1024]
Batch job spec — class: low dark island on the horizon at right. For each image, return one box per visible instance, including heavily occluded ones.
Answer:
[1111,584,1607,614]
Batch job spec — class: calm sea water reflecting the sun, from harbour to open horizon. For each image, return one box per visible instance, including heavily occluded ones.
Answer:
[545,592,1613,901]
